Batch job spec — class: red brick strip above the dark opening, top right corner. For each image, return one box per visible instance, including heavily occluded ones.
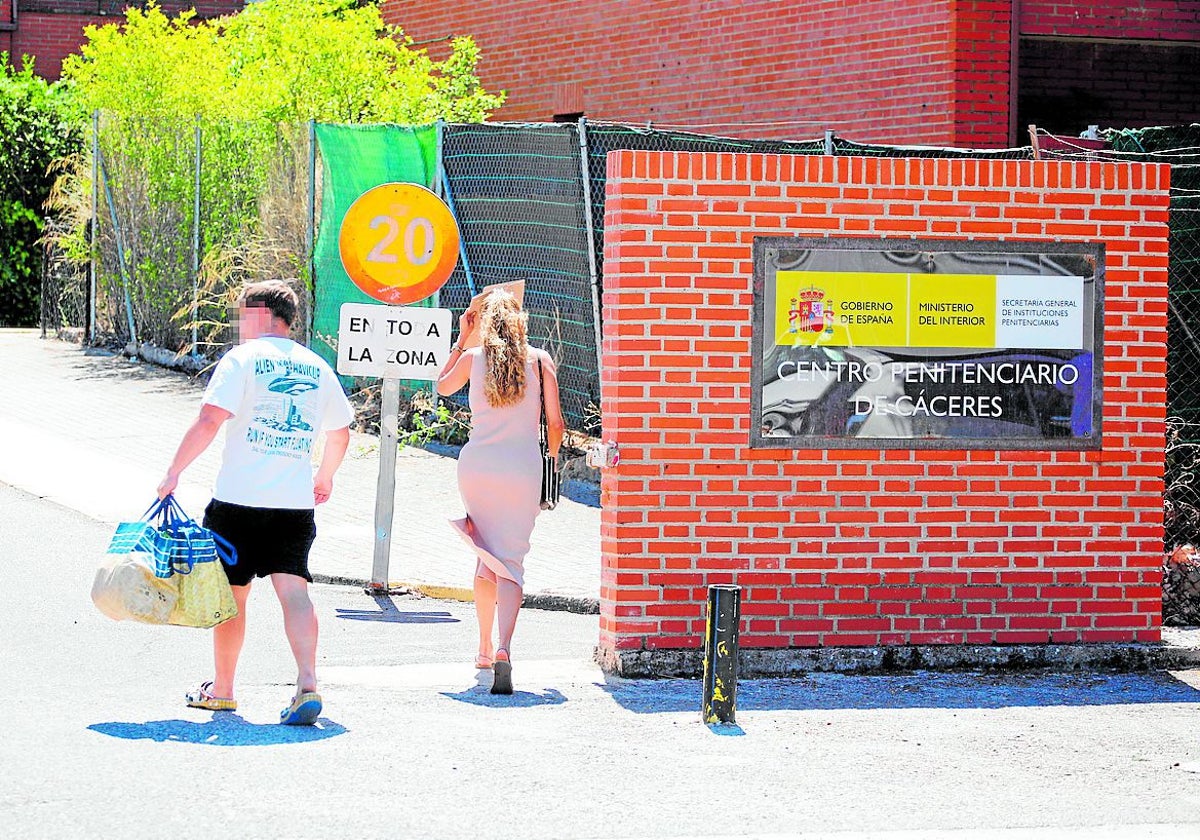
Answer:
[1021,0,1200,41]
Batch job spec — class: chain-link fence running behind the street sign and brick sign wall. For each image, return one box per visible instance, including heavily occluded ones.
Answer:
[35,116,1200,453]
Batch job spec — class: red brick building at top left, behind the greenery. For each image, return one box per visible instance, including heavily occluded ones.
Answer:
[0,0,246,79]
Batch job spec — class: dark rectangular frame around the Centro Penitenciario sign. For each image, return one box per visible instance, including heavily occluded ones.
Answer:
[749,236,1105,451]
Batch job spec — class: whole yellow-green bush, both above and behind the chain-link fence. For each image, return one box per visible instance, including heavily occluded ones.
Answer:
[54,0,504,346]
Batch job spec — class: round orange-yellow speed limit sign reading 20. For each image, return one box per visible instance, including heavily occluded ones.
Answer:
[337,184,458,306]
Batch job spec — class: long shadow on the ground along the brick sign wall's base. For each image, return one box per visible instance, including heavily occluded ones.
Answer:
[599,672,1200,714]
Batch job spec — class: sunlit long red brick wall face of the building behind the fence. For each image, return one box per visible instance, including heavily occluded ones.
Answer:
[384,0,960,144]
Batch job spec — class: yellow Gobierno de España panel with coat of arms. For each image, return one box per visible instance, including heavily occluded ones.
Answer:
[775,271,908,347]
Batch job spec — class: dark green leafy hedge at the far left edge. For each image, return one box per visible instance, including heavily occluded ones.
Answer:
[0,53,83,326]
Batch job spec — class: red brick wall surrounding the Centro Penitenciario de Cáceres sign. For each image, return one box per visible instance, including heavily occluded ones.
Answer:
[600,152,1169,662]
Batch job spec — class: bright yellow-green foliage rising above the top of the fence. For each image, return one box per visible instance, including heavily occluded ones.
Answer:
[64,0,503,124]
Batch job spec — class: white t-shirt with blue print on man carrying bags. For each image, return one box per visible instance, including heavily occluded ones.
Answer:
[204,336,354,509]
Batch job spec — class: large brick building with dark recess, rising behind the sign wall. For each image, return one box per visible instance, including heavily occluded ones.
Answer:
[384,0,1200,148]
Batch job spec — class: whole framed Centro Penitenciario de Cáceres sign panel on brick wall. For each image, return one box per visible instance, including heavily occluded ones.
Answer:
[750,236,1104,449]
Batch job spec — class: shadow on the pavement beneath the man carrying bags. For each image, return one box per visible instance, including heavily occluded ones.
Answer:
[88,712,347,746]
